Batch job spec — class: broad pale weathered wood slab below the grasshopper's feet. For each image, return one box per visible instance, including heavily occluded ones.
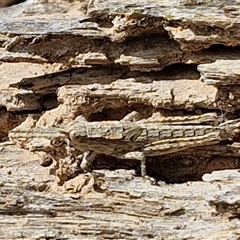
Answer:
[0,146,238,239]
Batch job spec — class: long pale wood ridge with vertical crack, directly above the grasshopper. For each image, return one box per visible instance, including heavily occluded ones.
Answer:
[58,79,217,114]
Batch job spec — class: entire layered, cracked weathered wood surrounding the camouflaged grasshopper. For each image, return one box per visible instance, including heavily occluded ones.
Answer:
[0,0,240,240]
